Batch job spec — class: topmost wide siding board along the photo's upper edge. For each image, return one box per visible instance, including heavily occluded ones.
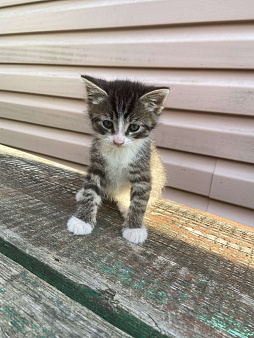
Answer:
[0,0,253,34]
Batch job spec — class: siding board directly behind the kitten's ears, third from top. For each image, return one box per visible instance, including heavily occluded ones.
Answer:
[0,64,254,116]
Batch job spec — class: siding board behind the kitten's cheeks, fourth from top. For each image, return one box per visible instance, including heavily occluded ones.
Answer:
[0,92,254,163]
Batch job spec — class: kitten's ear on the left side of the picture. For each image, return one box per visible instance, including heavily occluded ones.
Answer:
[81,75,108,104]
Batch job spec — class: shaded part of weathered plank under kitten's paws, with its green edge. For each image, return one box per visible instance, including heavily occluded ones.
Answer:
[0,155,254,338]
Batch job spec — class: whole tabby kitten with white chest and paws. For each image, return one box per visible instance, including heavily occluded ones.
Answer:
[67,75,169,244]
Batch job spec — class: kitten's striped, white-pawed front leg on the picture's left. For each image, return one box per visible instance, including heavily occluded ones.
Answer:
[67,167,103,235]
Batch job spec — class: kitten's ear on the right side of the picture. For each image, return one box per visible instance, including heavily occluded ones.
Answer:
[139,87,169,114]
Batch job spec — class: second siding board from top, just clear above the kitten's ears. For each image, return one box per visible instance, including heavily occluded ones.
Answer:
[0,24,254,69]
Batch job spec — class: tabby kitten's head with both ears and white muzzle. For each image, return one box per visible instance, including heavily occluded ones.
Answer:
[82,75,169,146]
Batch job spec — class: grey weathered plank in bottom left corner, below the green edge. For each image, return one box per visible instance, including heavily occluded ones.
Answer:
[0,254,130,338]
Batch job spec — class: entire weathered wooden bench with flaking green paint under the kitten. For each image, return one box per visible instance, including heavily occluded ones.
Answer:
[0,146,254,338]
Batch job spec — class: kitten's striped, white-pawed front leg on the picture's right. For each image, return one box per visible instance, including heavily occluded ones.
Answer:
[123,172,151,244]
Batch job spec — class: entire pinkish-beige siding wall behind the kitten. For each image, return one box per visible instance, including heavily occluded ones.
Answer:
[0,0,254,226]
